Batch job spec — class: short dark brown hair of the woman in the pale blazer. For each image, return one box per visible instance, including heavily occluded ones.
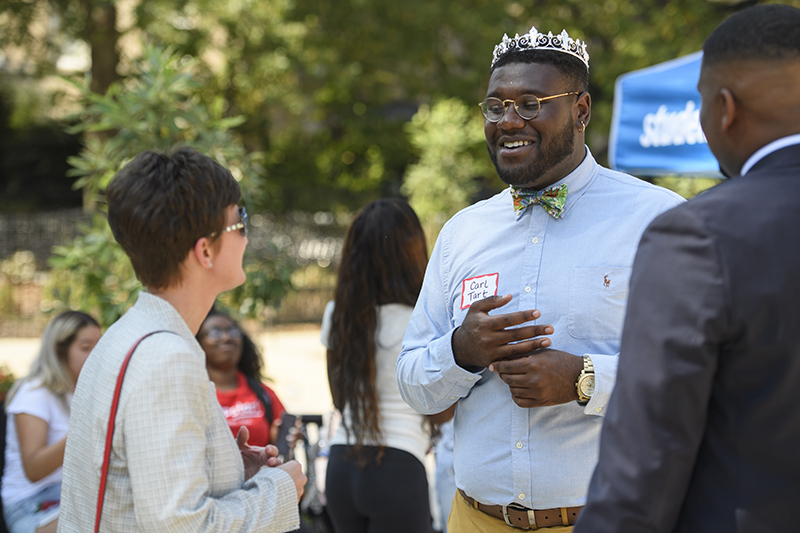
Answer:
[106,148,242,288]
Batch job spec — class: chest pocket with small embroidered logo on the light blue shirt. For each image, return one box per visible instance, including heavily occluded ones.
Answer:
[567,265,631,339]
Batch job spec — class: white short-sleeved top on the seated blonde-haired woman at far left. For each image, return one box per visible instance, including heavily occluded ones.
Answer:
[2,380,72,505]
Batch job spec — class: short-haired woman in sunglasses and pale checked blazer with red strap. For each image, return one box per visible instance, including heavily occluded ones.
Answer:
[59,148,305,533]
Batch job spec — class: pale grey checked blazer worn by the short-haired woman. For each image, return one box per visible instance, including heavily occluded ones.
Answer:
[58,292,299,533]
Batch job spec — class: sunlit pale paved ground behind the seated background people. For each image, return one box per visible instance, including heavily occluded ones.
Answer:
[0,325,333,414]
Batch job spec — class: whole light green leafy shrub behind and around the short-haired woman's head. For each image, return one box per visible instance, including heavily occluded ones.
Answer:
[50,47,291,325]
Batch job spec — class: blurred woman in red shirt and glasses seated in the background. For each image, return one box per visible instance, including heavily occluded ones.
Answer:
[197,309,286,446]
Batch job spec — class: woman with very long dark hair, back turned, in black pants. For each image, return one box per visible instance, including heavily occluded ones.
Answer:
[322,199,431,533]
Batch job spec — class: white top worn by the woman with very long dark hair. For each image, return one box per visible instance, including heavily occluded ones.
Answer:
[320,302,429,464]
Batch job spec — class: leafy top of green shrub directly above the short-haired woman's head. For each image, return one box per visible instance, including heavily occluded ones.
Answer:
[67,46,263,206]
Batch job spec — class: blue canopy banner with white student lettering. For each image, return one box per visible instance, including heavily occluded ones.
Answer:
[608,52,721,177]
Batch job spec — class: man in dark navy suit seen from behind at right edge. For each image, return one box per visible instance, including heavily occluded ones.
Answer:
[575,5,800,533]
